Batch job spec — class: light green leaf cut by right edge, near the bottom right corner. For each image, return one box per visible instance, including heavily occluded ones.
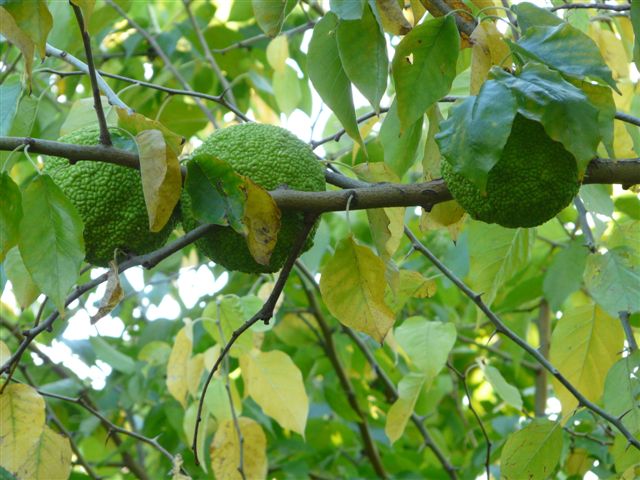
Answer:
[603,350,640,432]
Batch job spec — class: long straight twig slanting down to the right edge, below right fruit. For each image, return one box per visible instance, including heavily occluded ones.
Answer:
[404,227,640,450]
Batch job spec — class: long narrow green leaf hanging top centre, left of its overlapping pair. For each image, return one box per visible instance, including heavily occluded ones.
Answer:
[307,12,364,148]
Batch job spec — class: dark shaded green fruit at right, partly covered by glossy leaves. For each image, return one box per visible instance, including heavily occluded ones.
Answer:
[441,115,580,228]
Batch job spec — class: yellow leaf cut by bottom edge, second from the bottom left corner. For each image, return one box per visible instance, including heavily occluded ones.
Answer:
[16,425,71,480]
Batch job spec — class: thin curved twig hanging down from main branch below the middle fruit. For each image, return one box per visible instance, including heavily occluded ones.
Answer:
[191,214,318,465]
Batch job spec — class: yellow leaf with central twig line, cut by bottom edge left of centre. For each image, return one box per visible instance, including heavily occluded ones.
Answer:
[211,417,268,480]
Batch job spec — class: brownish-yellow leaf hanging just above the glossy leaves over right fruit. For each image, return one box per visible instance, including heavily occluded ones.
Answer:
[470,21,511,95]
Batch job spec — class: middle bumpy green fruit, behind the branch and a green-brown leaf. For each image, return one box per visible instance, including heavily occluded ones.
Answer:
[181,123,325,273]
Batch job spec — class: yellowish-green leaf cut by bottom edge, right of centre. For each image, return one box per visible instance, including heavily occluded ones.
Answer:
[500,419,562,480]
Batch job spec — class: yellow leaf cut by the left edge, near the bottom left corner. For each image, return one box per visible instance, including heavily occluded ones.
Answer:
[0,383,45,472]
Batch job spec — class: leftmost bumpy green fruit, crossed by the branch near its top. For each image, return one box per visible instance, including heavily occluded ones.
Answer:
[44,127,175,267]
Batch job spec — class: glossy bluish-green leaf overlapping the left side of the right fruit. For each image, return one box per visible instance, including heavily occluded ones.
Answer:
[435,80,516,190]
